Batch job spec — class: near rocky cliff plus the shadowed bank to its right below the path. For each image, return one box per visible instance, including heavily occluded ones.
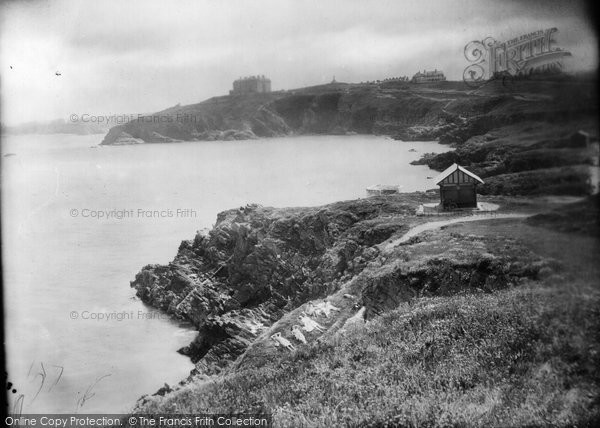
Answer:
[131,194,545,374]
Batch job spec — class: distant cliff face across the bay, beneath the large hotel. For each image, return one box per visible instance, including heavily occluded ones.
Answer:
[102,83,468,145]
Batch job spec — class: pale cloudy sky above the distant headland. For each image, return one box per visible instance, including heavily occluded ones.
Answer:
[0,0,598,125]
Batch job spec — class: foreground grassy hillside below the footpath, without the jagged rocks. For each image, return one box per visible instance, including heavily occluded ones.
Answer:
[130,196,600,427]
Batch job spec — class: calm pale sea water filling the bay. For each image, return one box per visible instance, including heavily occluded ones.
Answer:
[2,135,447,413]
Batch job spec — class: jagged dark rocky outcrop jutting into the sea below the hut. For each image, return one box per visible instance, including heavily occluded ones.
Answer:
[131,200,409,373]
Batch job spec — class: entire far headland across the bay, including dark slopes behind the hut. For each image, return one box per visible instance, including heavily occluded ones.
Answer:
[102,77,598,195]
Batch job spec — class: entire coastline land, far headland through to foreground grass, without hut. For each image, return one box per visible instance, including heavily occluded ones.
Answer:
[123,75,600,427]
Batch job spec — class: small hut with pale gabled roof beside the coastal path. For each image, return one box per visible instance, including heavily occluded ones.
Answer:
[435,164,483,209]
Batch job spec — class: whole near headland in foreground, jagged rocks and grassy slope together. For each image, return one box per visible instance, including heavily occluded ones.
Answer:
[132,193,600,427]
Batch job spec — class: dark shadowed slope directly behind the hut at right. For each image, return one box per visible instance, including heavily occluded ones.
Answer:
[426,116,597,195]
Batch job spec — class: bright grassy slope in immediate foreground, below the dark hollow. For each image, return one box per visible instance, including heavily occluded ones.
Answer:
[135,199,600,427]
